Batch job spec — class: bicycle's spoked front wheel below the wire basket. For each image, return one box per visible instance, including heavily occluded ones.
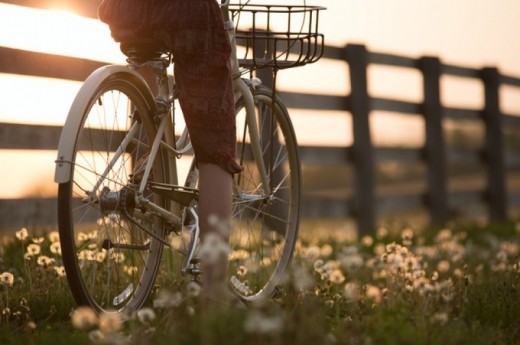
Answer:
[229,87,301,303]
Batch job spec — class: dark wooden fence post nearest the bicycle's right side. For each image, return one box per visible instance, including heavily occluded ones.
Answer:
[345,44,376,234]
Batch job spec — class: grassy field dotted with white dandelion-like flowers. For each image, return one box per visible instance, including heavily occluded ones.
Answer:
[0,220,520,345]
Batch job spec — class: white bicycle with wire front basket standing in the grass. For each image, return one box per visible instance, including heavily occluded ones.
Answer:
[51,0,323,312]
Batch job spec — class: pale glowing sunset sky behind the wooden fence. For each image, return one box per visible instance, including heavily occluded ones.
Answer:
[0,0,520,197]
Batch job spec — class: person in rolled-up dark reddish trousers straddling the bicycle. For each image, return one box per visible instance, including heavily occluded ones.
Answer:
[98,0,242,306]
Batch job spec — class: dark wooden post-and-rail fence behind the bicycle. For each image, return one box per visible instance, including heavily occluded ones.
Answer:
[0,0,520,232]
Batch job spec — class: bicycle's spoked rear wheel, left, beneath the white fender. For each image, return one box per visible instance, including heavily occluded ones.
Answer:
[58,73,168,312]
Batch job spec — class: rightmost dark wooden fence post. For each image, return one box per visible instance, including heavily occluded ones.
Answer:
[481,67,507,221]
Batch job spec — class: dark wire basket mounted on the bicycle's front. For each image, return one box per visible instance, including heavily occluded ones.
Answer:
[229,4,324,69]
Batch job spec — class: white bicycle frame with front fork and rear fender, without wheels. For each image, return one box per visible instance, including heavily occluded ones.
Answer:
[55,0,270,228]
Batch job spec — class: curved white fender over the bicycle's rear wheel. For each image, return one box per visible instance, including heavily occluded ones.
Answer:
[54,65,153,183]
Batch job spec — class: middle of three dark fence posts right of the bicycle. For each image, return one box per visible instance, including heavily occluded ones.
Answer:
[419,57,448,225]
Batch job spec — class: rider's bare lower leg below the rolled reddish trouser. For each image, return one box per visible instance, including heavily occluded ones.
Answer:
[199,164,232,301]
